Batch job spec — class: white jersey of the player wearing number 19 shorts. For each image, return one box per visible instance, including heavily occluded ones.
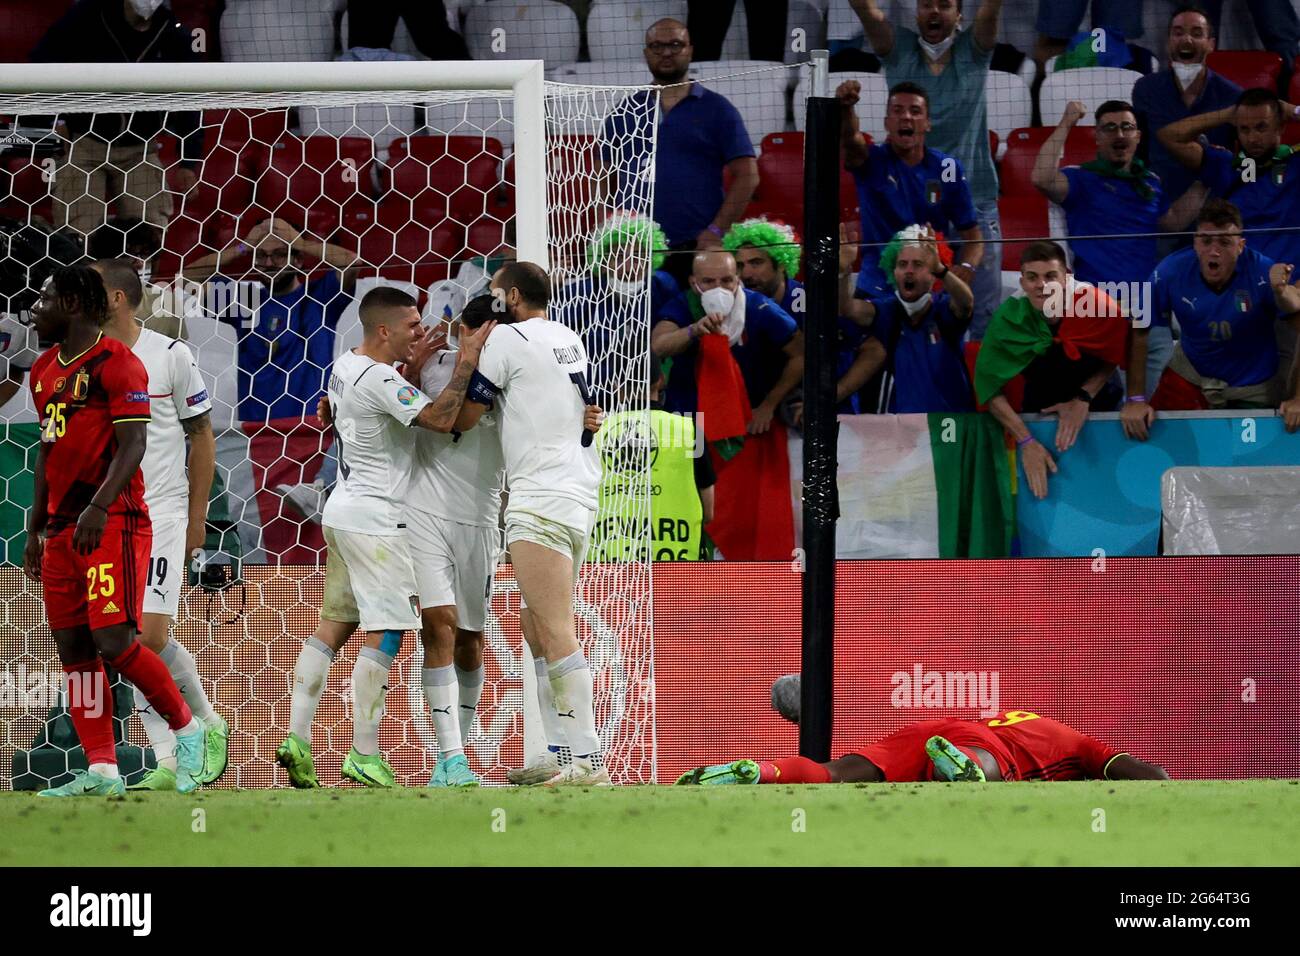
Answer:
[131,329,212,519]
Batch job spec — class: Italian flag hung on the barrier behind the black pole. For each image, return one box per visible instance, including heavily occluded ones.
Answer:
[789,412,1015,558]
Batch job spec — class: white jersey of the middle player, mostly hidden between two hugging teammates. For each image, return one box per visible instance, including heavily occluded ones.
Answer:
[407,350,506,528]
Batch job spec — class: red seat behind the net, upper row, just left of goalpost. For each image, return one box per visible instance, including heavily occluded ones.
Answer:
[385,135,502,228]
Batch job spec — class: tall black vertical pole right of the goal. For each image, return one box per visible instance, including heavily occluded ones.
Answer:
[800,78,840,762]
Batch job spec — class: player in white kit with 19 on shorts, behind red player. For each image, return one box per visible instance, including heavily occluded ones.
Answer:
[94,259,229,791]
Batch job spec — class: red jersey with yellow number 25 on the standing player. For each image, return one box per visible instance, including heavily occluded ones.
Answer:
[31,333,150,535]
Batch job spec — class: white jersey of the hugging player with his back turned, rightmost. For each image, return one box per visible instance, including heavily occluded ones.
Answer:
[478,319,601,511]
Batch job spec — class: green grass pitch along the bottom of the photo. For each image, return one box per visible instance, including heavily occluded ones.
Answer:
[0,780,1300,866]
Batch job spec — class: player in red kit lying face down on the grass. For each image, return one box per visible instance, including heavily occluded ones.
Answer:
[677,710,1169,786]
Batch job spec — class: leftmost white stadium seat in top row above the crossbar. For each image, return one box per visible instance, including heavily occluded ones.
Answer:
[221,0,334,62]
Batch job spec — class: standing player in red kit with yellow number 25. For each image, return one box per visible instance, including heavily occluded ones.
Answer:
[23,265,203,796]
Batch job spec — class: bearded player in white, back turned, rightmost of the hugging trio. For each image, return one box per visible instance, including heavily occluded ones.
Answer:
[456,261,610,786]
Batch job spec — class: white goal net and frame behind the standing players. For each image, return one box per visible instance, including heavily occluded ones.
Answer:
[0,62,657,788]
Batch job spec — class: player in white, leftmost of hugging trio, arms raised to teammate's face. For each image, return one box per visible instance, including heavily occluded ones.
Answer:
[276,286,491,787]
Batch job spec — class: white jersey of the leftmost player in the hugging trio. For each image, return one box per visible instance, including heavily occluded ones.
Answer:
[321,351,429,535]
